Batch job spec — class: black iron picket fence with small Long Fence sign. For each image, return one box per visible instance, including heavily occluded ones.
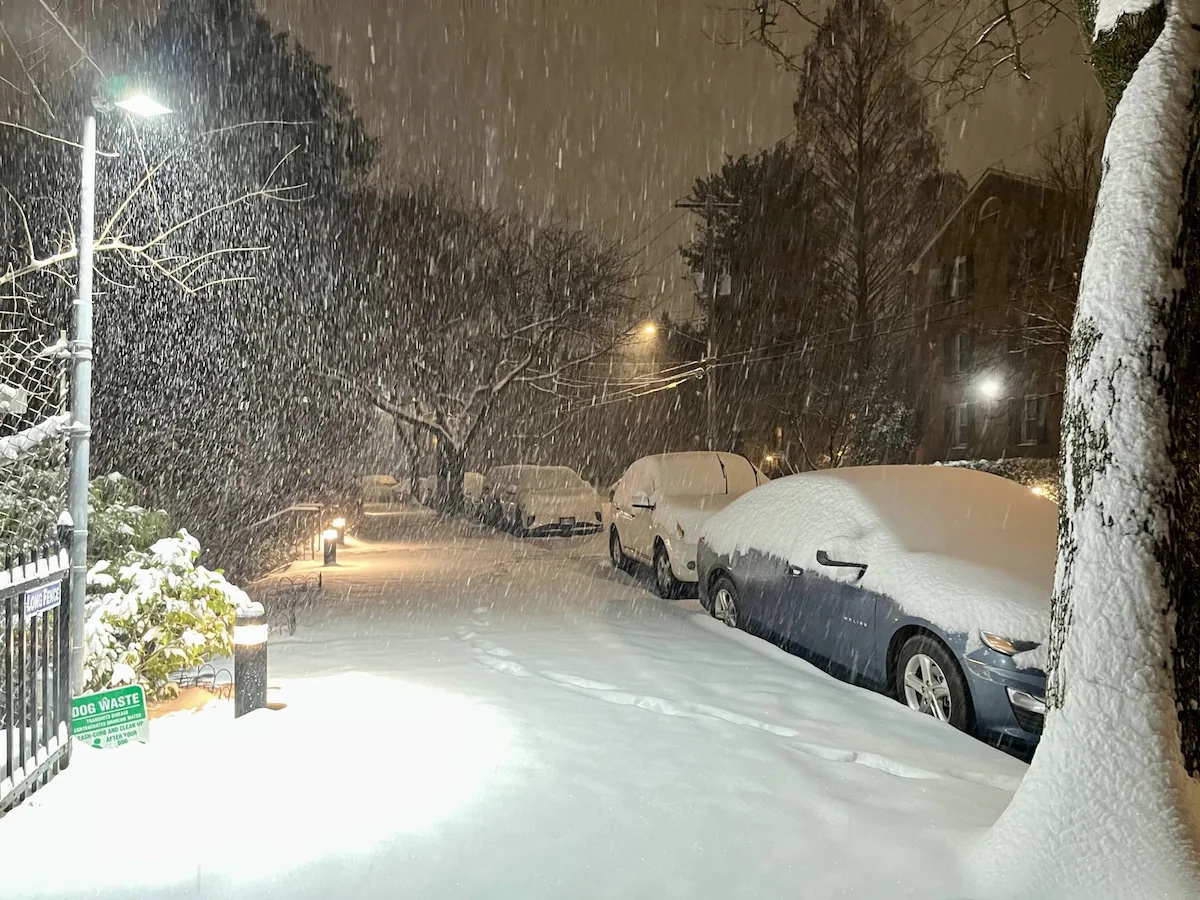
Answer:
[0,545,71,816]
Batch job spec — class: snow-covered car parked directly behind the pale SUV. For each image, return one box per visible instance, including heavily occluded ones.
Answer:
[484,466,602,534]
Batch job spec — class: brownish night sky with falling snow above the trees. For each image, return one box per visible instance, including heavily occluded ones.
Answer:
[5,0,1099,313]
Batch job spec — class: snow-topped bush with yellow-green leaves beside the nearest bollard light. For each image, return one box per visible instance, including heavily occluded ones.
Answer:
[84,530,250,696]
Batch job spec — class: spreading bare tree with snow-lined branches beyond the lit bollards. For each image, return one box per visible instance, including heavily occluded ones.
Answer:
[329,188,629,511]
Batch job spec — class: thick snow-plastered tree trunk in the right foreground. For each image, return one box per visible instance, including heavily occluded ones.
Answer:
[968,0,1200,898]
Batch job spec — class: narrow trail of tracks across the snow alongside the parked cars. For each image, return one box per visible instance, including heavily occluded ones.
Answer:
[455,606,1019,791]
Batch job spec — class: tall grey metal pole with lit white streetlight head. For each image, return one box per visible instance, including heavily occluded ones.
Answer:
[67,78,170,692]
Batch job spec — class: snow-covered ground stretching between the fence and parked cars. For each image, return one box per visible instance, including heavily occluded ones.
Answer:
[0,514,1025,900]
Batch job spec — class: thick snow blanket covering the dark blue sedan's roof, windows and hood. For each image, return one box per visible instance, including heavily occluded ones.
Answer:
[704,466,1057,641]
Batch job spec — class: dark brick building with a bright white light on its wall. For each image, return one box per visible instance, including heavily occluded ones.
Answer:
[908,169,1086,463]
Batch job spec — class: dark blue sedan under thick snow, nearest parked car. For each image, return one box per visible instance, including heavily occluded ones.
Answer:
[698,466,1058,748]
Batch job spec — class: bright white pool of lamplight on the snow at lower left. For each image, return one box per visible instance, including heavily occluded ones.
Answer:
[0,673,511,896]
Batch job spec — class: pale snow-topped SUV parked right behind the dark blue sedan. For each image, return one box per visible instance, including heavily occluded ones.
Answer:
[608,450,768,598]
